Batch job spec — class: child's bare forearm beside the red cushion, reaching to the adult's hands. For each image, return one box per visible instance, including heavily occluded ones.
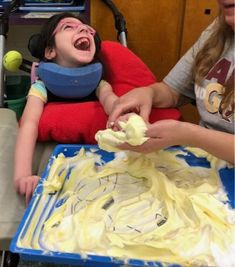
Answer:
[96,80,118,115]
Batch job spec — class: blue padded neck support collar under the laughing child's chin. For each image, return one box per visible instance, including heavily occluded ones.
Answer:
[37,62,102,98]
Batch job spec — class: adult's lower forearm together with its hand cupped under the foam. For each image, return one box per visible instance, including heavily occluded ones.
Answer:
[120,120,235,164]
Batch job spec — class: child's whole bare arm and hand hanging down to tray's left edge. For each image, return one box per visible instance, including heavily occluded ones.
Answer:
[13,96,44,204]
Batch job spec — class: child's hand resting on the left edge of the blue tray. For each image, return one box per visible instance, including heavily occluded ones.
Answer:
[14,175,40,206]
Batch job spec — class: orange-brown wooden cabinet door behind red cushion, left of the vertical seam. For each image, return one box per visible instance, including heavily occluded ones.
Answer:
[90,0,184,80]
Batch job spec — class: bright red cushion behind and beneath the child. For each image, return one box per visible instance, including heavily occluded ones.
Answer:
[38,41,180,144]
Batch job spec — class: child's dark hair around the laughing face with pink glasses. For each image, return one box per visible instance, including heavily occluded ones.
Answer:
[28,12,101,61]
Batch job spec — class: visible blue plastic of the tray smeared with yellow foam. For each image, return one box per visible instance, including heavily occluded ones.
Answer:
[10,145,235,267]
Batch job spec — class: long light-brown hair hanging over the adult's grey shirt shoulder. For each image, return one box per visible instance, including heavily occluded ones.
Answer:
[193,12,234,85]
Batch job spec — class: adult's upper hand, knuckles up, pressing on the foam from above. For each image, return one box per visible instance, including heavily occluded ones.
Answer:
[107,87,153,127]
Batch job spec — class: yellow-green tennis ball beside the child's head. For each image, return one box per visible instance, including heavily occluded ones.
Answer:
[3,50,23,72]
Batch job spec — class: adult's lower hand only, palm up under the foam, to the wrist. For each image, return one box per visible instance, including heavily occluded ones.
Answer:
[119,120,187,153]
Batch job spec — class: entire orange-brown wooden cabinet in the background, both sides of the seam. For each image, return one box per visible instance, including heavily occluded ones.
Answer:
[90,0,218,123]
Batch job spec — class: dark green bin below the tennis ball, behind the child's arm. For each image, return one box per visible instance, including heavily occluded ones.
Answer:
[5,75,30,120]
